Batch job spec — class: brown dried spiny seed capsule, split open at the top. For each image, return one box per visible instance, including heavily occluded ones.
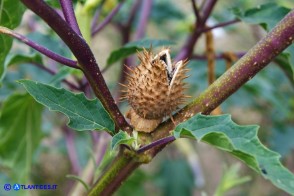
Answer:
[123,48,188,132]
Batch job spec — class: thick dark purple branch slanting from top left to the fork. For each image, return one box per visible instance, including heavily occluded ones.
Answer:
[21,0,132,132]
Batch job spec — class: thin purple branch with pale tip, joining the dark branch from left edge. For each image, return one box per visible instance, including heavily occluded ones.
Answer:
[0,27,80,69]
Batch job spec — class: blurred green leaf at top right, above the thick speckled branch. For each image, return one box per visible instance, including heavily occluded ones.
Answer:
[233,3,290,31]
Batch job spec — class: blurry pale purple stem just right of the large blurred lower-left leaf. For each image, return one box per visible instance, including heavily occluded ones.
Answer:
[63,126,81,174]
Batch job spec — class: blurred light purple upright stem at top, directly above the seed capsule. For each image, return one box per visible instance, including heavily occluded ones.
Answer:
[134,0,152,40]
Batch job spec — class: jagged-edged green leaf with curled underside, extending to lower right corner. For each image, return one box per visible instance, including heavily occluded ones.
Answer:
[174,114,294,194]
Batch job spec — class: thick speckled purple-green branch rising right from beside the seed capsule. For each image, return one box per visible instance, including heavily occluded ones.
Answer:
[152,10,294,151]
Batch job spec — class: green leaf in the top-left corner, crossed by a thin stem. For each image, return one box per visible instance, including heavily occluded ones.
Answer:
[0,0,25,82]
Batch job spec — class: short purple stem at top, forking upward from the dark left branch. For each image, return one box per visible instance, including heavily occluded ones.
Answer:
[59,0,82,36]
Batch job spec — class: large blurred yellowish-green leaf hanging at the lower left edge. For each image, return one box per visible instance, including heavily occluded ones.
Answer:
[0,94,42,183]
